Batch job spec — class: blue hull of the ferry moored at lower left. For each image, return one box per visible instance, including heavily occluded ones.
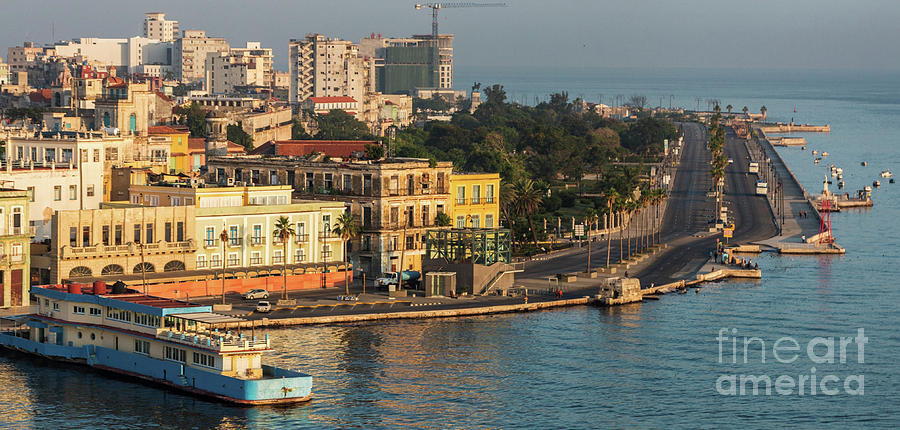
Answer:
[0,333,312,406]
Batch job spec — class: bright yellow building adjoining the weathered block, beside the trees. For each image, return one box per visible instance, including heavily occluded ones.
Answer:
[450,173,500,228]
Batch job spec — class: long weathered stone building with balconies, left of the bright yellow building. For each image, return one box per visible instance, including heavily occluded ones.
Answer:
[207,156,452,276]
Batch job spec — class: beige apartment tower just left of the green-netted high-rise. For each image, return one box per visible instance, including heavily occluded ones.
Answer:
[288,34,375,104]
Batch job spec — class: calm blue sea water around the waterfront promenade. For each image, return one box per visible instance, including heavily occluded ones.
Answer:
[0,69,900,429]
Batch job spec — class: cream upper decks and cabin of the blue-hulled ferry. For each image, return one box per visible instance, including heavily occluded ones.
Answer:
[26,283,271,379]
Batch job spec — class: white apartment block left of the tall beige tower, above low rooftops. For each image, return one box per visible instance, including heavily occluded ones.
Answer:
[204,42,272,94]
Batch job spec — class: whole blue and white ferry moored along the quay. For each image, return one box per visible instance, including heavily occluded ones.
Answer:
[0,283,312,405]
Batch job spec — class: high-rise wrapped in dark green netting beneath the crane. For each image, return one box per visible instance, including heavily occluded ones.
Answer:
[359,34,453,94]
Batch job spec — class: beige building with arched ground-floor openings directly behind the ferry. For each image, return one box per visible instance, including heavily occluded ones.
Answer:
[49,206,197,284]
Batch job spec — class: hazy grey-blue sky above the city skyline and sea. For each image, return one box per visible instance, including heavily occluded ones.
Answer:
[0,0,900,70]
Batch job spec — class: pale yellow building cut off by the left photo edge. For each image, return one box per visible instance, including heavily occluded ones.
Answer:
[0,189,31,308]
